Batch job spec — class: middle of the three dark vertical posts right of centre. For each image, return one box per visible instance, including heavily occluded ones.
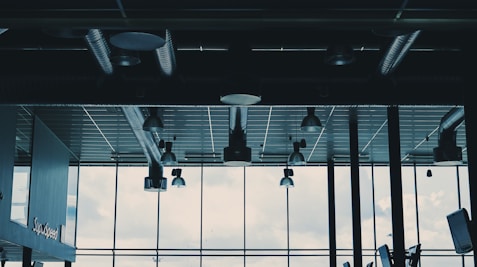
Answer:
[349,107,363,266]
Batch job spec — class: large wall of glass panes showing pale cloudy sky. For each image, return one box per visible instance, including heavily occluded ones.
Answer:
[69,165,473,267]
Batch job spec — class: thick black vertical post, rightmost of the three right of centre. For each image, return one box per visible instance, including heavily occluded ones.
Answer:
[388,106,406,267]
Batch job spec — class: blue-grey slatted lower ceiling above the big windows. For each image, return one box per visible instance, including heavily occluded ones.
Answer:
[13,105,466,168]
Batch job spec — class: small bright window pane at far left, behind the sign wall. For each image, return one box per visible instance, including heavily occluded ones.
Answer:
[10,166,31,226]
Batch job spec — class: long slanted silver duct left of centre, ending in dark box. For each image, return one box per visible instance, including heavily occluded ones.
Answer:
[122,107,167,192]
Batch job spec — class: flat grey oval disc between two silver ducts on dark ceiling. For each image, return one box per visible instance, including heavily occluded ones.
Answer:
[109,32,165,51]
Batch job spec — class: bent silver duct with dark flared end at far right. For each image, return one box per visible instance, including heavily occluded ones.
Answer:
[433,107,464,165]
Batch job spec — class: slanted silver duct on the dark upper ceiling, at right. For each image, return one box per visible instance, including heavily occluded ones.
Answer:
[379,30,421,76]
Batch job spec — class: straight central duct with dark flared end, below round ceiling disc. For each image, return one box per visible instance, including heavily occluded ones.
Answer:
[224,106,252,166]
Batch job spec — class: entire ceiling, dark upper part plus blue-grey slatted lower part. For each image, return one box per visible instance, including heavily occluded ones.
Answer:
[0,0,477,164]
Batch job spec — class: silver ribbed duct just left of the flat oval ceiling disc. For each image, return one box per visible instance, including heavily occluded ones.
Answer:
[85,29,113,75]
